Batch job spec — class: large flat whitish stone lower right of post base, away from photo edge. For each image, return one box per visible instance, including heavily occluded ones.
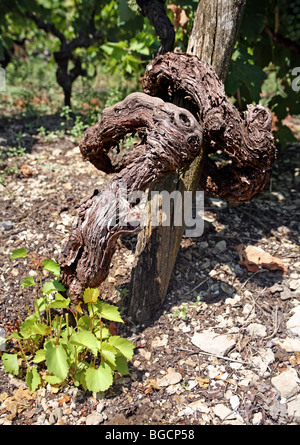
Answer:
[191,330,235,356]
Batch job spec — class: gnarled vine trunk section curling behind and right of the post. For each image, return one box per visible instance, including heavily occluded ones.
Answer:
[142,53,275,202]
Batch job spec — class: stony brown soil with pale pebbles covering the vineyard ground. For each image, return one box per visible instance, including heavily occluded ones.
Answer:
[0,122,300,425]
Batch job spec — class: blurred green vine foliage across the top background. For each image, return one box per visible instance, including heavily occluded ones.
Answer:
[0,0,300,146]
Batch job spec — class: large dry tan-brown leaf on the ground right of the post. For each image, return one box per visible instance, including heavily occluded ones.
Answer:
[233,245,288,273]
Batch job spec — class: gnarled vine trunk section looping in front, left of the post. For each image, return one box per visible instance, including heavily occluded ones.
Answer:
[60,93,202,302]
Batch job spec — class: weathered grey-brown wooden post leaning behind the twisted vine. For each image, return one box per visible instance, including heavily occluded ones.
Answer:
[127,0,246,323]
